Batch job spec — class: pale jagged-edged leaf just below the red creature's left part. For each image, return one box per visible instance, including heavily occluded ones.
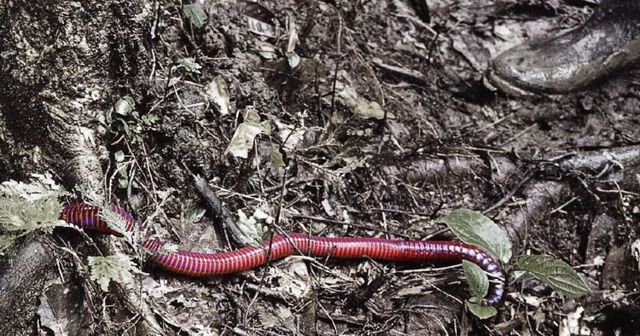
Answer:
[89,253,141,292]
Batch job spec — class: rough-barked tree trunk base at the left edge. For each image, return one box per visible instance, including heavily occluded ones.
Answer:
[0,0,153,335]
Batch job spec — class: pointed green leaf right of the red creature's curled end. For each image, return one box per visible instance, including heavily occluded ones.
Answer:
[516,255,590,298]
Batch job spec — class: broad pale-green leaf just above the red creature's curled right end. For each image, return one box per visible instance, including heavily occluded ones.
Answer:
[442,209,512,264]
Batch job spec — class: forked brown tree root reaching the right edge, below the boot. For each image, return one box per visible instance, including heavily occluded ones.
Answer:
[380,145,640,252]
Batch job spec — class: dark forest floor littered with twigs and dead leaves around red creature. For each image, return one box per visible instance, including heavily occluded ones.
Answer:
[3,0,640,335]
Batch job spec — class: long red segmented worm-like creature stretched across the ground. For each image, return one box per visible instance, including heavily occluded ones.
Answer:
[60,203,505,306]
